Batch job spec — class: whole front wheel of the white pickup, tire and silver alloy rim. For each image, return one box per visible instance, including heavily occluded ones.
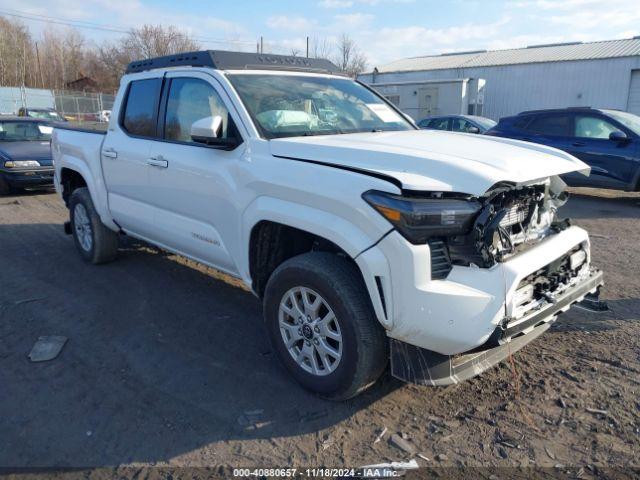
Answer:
[264,252,388,400]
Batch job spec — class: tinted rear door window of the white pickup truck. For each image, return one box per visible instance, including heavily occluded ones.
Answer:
[122,78,161,137]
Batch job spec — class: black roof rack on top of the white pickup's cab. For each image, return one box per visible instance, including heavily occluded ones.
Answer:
[125,50,343,75]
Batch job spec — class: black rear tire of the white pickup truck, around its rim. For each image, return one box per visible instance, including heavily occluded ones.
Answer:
[69,188,118,265]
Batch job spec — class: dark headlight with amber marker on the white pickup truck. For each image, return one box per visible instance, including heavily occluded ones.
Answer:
[362,190,481,244]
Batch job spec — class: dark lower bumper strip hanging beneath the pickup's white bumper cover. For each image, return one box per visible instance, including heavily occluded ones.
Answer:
[391,269,602,386]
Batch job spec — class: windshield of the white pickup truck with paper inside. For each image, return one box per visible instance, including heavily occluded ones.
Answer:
[229,73,414,138]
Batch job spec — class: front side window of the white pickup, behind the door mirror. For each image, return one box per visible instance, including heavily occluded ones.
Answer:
[164,78,238,142]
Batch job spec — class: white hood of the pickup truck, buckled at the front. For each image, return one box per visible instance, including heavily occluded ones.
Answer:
[269,130,589,195]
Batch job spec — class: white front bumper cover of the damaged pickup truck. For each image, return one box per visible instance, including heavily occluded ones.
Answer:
[356,226,590,355]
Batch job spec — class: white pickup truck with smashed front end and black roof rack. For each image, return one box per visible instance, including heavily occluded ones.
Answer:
[52,51,602,399]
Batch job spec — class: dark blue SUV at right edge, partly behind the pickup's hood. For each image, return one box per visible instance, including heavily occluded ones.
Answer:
[486,107,640,191]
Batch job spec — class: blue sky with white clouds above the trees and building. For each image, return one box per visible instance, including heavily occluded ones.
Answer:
[0,0,640,69]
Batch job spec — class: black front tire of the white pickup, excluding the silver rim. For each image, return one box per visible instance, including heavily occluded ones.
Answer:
[264,252,388,400]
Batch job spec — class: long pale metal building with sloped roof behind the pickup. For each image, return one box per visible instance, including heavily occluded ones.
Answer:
[358,37,640,120]
